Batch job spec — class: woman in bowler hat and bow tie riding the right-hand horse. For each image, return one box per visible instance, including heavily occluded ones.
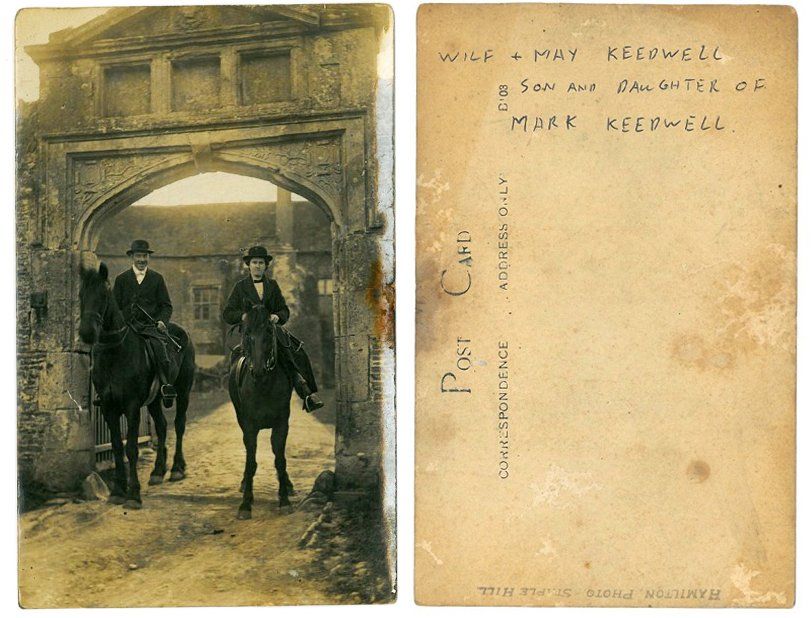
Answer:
[223,246,324,412]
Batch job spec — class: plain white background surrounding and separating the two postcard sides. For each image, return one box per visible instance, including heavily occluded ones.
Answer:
[0,0,812,618]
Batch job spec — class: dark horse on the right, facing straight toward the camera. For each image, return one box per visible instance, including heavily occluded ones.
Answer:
[228,305,293,519]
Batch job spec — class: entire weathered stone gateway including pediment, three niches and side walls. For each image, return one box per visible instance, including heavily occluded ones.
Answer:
[17,5,393,490]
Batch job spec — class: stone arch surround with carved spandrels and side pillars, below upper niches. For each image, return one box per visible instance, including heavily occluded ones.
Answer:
[27,116,385,490]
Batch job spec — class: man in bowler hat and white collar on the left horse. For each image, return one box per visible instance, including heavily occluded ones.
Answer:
[113,240,177,408]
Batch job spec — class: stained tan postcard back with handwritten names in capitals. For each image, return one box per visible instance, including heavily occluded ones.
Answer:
[415,4,797,607]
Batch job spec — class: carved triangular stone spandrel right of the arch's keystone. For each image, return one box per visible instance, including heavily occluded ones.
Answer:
[221,137,343,197]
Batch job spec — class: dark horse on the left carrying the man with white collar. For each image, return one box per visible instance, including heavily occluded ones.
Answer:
[79,264,195,508]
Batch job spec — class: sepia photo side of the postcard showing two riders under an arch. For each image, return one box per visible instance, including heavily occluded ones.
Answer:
[16,4,395,608]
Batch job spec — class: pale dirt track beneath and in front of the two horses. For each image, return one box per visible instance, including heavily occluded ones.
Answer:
[19,388,374,607]
